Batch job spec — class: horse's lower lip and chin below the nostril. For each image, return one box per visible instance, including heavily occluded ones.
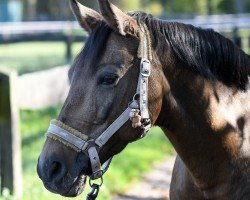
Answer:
[44,175,87,197]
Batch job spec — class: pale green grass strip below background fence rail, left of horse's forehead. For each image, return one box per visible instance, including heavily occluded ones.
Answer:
[0,42,83,74]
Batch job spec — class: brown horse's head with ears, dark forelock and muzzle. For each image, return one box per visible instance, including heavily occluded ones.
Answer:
[37,0,163,196]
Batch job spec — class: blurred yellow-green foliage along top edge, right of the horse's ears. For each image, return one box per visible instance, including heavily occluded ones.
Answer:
[112,0,250,17]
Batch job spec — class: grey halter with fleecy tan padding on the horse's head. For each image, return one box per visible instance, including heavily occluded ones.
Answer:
[46,24,152,180]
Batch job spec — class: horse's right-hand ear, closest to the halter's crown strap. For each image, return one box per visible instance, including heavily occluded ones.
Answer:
[98,0,139,37]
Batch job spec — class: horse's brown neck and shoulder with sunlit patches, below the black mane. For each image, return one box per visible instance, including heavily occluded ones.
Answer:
[157,66,250,199]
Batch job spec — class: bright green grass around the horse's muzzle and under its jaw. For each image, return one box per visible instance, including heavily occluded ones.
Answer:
[21,108,173,200]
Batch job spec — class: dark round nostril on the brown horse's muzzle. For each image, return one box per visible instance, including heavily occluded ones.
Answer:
[47,161,66,182]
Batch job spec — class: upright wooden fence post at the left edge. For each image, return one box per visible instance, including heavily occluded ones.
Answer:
[0,68,22,198]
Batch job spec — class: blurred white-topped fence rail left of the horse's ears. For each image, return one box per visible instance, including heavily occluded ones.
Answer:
[0,21,87,61]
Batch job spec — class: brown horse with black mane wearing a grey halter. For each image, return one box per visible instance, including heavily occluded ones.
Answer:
[37,0,250,200]
